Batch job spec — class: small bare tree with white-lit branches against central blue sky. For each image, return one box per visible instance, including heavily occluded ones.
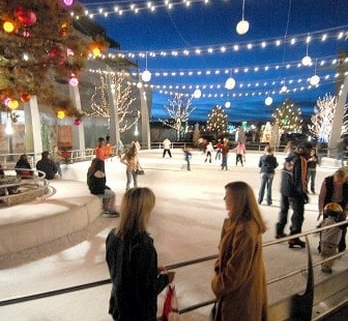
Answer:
[159,94,196,141]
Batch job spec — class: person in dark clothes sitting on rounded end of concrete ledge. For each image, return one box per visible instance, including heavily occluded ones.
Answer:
[87,158,119,217]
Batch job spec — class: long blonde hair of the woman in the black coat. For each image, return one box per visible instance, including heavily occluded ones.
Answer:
[116,187,156,238]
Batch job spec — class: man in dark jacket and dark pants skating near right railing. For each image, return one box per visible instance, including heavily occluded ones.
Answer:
[276,145,308,248]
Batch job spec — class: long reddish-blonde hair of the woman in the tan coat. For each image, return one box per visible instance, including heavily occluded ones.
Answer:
[225,181,266,234]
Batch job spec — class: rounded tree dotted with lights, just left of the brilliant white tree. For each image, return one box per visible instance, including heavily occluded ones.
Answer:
[272,99,303,133]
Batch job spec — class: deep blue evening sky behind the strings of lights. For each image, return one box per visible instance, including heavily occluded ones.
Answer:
[80,0,348,121]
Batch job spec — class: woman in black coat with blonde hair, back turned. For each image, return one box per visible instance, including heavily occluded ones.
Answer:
[106,187,174,321]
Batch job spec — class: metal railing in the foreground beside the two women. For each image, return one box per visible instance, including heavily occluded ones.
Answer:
[0,221,347,321]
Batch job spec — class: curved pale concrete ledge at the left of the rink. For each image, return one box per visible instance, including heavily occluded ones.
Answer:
[0,180,102,258]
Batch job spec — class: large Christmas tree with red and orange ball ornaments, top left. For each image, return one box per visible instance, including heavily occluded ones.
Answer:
[0,0,102,105]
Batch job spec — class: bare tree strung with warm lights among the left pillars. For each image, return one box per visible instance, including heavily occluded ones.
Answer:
[84,73,140,133]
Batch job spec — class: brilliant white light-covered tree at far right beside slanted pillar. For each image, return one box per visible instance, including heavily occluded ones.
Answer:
[308,94,337,143]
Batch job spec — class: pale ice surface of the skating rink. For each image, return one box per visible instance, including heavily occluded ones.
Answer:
[0,150,347,321]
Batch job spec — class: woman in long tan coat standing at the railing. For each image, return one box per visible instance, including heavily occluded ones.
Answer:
[211,182,268,321]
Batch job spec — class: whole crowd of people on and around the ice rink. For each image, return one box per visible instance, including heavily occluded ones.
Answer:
[1,137,348,321]
